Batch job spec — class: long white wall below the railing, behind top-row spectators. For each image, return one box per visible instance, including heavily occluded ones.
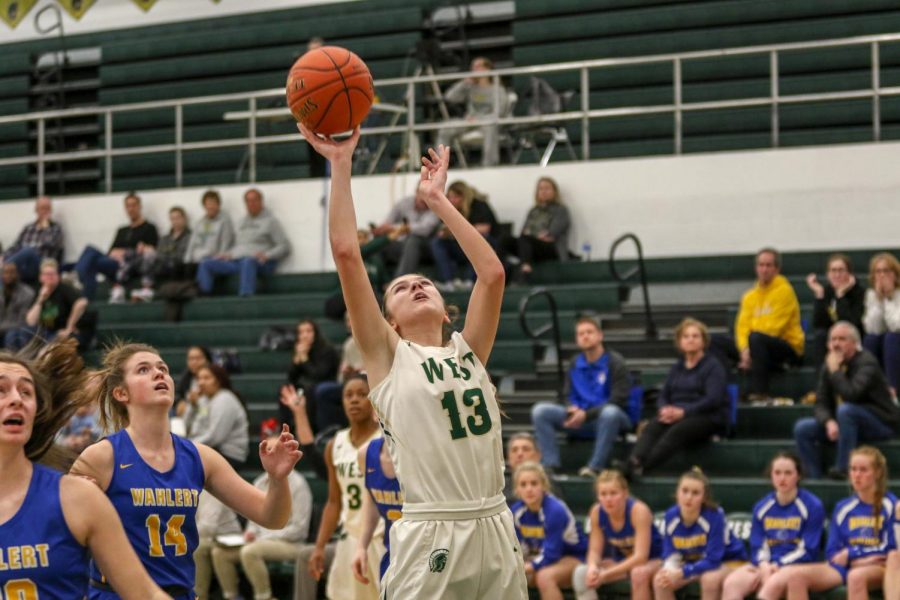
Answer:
[0,142,900,271]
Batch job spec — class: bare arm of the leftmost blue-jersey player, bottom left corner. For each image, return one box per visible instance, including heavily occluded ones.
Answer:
[59,477,171,600]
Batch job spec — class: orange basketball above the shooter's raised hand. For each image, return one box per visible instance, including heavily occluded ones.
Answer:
[286,46,375,135]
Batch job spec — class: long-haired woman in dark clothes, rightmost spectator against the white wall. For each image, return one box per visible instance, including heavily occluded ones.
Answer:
[518,177,571,283]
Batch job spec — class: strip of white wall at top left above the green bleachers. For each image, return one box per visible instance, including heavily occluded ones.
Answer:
[0,0,352,45]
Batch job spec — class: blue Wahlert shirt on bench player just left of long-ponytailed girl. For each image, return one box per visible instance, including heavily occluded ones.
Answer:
[750,488,825,566]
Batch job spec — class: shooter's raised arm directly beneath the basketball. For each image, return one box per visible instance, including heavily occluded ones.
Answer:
[298,125,399,386]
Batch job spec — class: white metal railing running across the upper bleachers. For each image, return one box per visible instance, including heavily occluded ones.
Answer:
[0,34,900,194]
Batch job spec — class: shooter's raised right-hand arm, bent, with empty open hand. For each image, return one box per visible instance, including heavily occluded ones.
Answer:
[419,145,506,365]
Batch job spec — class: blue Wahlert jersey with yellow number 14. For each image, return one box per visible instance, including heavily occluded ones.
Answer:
[90,430,205,600]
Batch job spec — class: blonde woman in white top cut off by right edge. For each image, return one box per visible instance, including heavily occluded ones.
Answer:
[863,252,900,398]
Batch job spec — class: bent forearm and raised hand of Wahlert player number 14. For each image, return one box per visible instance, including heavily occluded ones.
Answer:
[197,425,303,529]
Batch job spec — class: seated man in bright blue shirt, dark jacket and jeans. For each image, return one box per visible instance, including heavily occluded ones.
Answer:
[531,316,634,478]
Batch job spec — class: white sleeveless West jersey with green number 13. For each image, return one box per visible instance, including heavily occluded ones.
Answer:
[369,332,503,506]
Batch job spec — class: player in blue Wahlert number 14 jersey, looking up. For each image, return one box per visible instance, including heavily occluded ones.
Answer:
[72,342,301,600]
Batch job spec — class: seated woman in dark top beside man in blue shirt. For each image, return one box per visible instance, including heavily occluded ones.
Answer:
[627,318,729,475]
